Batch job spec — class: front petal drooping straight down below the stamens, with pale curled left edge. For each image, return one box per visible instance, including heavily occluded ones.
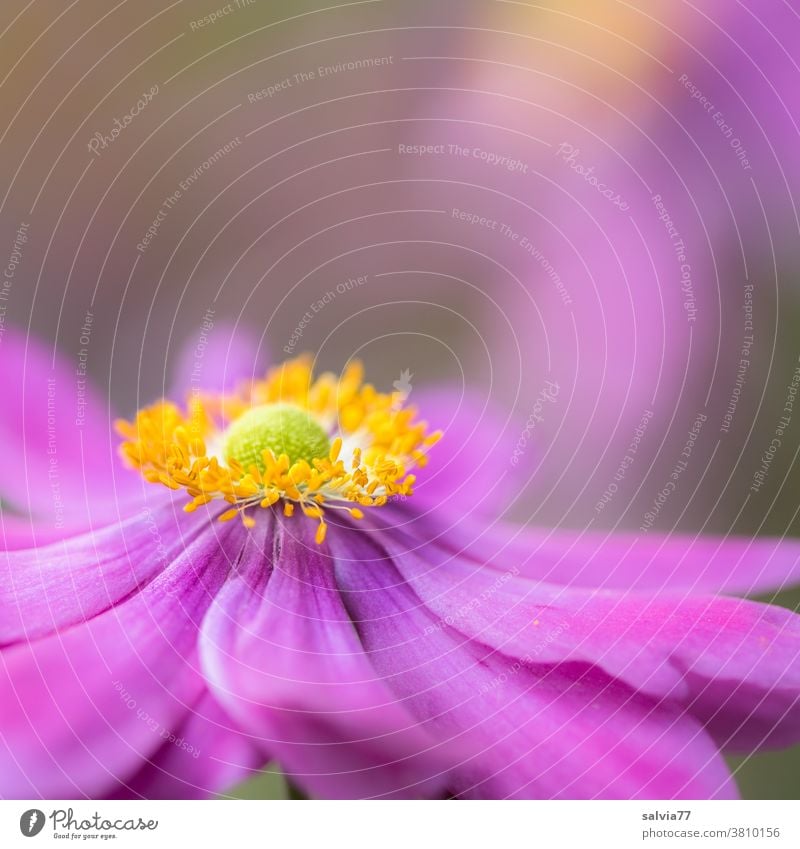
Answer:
[201,519,454,798]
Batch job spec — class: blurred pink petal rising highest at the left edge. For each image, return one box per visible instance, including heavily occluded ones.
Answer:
[0,328,142,528]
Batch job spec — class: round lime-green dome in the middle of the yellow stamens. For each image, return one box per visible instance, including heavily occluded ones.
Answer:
[222,404,331,472]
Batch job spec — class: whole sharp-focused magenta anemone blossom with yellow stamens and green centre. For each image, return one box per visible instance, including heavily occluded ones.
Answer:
[0,333,800,798]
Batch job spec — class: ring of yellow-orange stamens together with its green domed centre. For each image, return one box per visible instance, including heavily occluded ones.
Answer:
[116,356,441,543]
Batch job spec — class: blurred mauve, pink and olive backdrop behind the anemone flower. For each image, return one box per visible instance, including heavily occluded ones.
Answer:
[0,0,800,798]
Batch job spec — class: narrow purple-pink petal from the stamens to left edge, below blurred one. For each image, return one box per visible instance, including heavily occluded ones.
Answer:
[0,494,208,644]
